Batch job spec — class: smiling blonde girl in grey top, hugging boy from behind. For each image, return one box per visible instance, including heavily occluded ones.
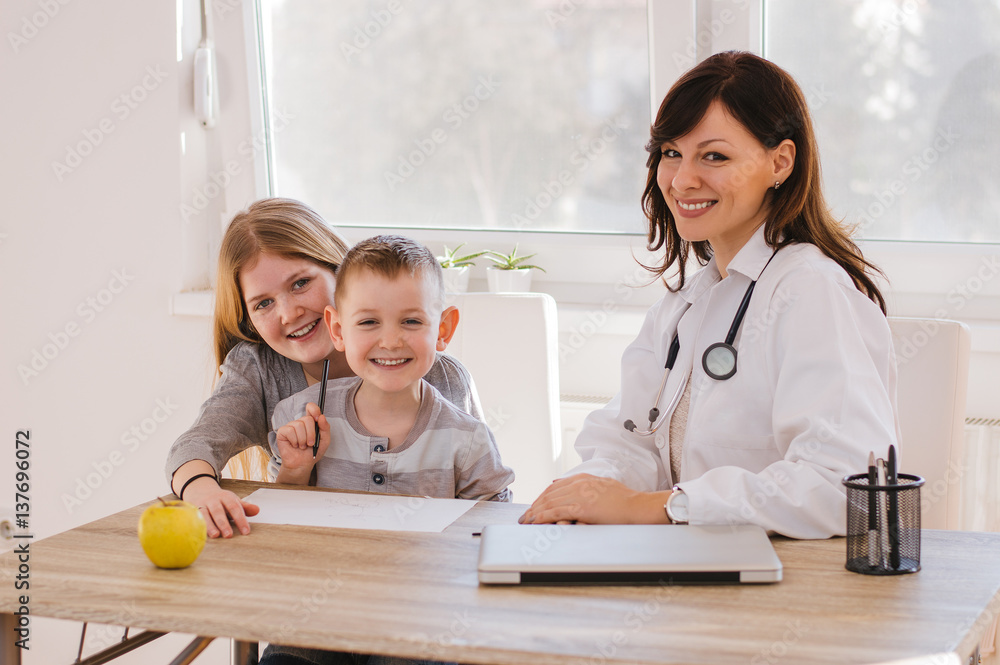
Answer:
[166,198,482,538]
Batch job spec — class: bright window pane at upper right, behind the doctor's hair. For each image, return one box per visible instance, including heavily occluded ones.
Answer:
[765,0,1000,242]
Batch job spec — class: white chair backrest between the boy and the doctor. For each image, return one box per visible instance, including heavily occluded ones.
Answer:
[446,293,562,503]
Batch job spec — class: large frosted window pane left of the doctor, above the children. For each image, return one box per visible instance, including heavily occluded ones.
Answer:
[262,0,649,233]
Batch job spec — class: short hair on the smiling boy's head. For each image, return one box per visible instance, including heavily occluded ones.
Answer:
[333,235,444,307]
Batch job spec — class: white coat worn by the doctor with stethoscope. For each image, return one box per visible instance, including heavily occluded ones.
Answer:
[567,228,899,538]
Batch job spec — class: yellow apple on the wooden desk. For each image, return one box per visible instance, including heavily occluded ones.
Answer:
[139,499,206,568]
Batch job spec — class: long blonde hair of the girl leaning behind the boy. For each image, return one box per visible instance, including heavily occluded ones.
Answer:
[212,198,348,478]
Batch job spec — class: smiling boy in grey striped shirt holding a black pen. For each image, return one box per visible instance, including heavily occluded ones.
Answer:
[270,236,514,501]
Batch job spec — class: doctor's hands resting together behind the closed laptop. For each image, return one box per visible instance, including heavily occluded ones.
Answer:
[518,473,670,524]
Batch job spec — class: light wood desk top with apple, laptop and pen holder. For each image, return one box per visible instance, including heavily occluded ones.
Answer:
[0,482,1000,665]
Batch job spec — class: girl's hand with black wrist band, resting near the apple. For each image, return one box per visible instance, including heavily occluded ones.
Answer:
[173,460,260,538]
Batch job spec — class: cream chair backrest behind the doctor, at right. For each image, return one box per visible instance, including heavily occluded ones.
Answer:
[889,317,971,529]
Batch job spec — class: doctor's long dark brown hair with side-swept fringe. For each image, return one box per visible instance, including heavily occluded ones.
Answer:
[642,51,886,313]
